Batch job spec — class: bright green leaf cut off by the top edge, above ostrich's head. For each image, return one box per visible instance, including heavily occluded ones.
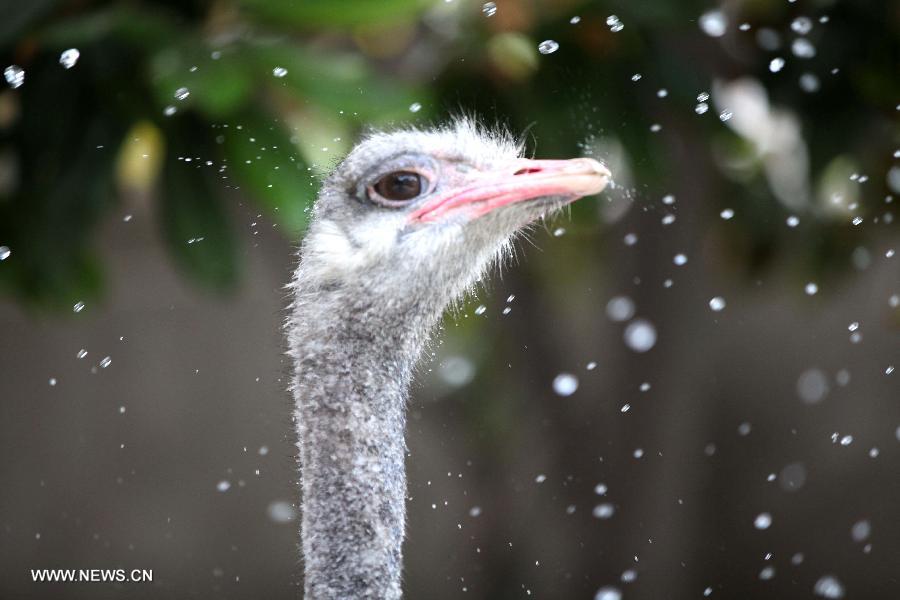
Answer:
[239,0,433,29]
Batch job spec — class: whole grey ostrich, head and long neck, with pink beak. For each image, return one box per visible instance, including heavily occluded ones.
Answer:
[287,120,610,600]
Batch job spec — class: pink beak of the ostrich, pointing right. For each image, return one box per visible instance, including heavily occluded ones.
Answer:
[409,158,612,223]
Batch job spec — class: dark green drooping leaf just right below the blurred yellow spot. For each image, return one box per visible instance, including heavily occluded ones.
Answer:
[160,144,237,291]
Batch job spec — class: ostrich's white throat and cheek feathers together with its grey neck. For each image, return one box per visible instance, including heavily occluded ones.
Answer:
[287,161,527,600]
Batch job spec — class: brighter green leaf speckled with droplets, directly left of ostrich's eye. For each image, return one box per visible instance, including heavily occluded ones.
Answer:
[219,114,318,236]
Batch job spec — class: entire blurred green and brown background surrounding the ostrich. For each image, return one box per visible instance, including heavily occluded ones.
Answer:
[0,0,900,600]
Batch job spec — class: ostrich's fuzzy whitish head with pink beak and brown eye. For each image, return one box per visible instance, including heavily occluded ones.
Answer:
[303,120,610,311]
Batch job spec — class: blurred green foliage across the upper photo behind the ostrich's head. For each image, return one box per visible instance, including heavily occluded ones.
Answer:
[0,0,900,307]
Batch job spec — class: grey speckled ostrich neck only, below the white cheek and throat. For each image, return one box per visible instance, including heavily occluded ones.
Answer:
[289,278,443,600]
